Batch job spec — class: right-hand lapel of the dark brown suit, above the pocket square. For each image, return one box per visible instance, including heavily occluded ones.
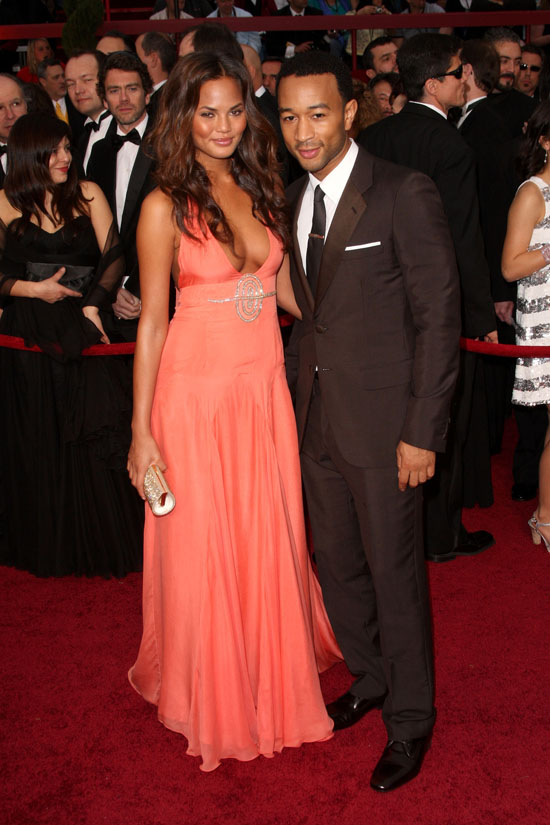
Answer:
[315,149,372,306]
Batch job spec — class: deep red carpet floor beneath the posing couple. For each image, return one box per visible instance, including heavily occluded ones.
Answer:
[0,418,550,825]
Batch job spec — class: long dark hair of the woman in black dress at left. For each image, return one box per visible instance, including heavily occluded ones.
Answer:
[4,114,89,235]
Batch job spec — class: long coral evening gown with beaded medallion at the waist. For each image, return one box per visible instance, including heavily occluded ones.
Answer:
[129,222,341,771]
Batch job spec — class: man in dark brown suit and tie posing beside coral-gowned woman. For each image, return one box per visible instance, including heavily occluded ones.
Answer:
[278,52,459,791]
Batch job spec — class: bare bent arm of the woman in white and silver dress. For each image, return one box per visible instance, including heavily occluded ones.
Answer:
[501,182,548,282]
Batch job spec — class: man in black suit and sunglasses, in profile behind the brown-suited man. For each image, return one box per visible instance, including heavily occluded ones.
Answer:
[359,34,497,561]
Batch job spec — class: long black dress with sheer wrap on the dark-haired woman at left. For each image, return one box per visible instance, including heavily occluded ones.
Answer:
[0,215,143,577]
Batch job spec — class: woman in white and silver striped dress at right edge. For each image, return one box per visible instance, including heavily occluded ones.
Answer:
[502,102,550,552]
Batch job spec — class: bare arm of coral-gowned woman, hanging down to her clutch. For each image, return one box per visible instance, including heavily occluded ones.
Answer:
[128,189,175,498]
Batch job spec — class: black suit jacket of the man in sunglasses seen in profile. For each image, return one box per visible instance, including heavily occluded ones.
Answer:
[359,103,496,338]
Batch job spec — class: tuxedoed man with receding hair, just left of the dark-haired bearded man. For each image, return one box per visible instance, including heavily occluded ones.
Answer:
[65,50,113,174]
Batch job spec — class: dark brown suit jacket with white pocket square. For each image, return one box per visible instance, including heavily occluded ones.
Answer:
[288,149,460,467]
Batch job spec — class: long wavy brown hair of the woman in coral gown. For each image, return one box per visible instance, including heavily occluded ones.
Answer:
[152,53,289,248]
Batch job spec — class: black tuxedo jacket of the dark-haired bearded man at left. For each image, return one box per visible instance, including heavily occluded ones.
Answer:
[87,119,156,298]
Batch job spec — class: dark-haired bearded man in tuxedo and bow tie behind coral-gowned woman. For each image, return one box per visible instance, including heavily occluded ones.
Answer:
[88,52,155,341]
